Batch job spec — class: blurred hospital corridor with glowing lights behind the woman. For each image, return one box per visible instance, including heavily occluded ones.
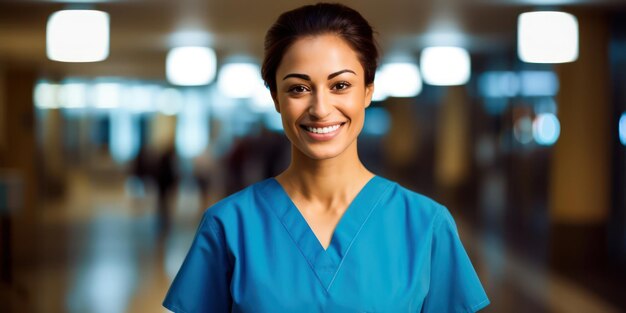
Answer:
[0,0,626,313]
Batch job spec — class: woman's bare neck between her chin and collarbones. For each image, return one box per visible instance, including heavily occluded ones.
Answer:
[276,141,374,210]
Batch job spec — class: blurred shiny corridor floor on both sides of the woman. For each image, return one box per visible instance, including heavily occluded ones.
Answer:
[0,168,619,313]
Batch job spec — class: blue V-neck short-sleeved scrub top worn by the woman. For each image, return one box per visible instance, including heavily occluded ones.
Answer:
[163,176,489,313]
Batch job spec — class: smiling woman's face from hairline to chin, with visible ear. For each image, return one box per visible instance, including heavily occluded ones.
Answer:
[273,34,374,160]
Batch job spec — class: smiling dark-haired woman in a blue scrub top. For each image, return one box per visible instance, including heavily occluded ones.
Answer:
[164,4,489,312]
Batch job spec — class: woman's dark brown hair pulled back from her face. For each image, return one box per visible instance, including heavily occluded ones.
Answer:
[261,3,378,93]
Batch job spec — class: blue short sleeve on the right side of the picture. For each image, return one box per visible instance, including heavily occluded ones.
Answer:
[422,207,489,313]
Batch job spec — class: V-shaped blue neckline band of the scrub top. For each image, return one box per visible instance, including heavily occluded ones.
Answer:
[262,175,385,291]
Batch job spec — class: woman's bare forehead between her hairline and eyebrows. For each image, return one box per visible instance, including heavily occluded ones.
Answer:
[276,34,364,80]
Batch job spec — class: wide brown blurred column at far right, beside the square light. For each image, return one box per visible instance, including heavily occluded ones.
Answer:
[549,12,612,269]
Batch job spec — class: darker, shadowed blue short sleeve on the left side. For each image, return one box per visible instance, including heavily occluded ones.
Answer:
[163,214,232,313]
